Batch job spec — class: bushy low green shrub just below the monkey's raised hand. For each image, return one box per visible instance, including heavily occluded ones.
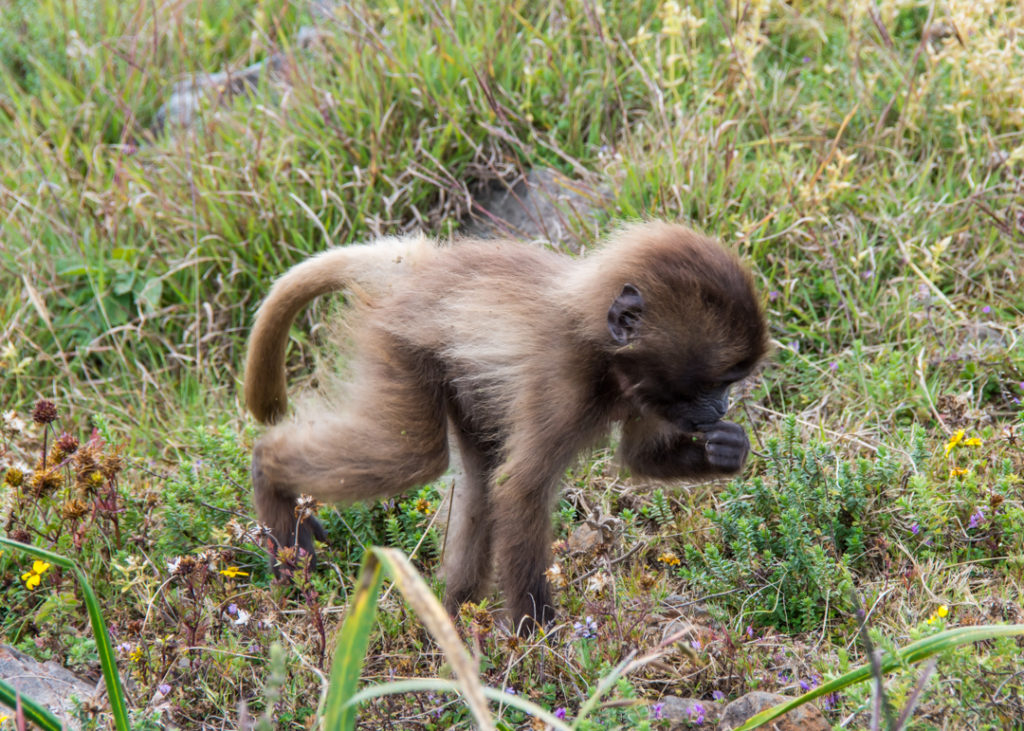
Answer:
[680,420,901,631]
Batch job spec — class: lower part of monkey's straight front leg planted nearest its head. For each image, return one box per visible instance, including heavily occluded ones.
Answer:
[492,464,560,635]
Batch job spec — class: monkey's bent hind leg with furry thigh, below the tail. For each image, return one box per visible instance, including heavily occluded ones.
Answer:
[252,357,449,565]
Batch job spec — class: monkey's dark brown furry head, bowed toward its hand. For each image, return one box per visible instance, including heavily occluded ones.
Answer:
[605,224,768,431]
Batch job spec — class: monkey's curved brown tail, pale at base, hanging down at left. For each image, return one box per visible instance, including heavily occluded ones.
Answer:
[245,237,431,424]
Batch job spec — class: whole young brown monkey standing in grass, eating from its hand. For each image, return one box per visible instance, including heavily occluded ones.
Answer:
[245,223,766,629]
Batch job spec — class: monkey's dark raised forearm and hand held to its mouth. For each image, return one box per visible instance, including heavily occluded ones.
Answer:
[621,418,751,478]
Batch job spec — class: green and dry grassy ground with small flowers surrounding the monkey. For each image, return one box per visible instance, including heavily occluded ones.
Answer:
[0,0,1024,729]
